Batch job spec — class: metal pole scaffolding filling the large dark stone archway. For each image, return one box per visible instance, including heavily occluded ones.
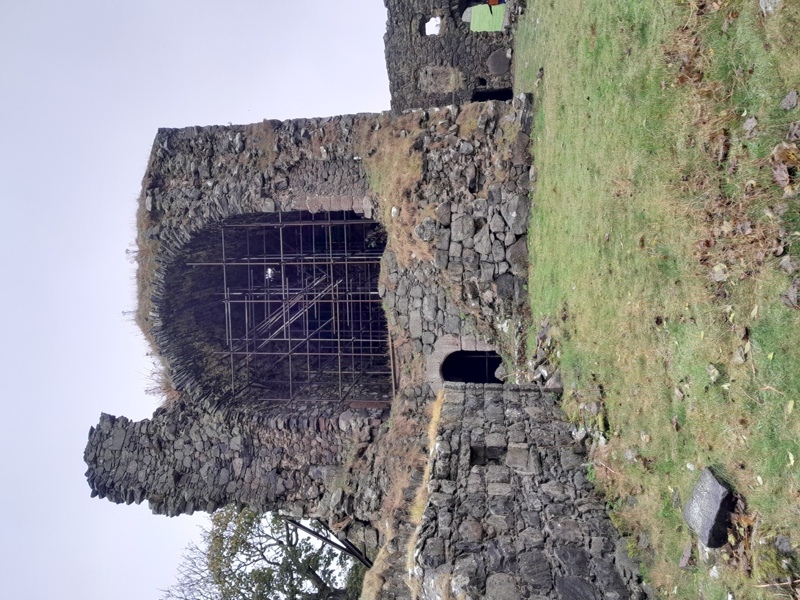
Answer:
[188,211,395,406]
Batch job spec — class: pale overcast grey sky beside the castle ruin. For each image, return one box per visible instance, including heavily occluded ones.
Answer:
[0,0,389,600]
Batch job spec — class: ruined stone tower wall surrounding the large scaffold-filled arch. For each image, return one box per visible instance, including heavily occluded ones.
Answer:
[85,97,531,551]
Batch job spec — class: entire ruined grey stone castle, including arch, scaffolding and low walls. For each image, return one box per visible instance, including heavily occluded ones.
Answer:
[84,0,642,600]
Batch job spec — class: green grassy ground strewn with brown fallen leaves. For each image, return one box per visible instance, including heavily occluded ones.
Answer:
[515,0,800,598]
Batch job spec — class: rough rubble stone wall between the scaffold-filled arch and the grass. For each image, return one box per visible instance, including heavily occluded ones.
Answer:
[379,96,532,372]
